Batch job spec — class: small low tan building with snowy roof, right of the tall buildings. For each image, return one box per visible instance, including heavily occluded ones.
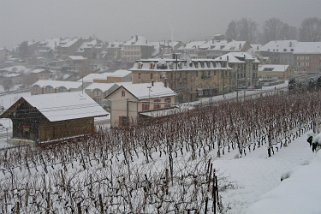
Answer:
[257,64,293,80]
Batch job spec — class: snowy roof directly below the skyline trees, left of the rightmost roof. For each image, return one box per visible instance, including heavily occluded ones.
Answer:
[261,40,298,53]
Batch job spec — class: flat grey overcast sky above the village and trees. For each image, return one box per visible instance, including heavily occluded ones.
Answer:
[0,0,321,48]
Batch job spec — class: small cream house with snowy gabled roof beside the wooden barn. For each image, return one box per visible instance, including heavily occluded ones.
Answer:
[106,82,176,127]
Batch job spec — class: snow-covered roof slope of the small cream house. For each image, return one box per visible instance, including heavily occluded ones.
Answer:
[114,82,176,100]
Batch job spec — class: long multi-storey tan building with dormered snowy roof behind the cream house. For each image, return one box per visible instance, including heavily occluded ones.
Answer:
[130,54,232,102]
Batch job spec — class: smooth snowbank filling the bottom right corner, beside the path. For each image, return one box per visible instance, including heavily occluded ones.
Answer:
[247,151,321,214]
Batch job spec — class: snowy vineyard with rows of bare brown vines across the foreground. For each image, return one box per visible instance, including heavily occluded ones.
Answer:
[0,92,321,213]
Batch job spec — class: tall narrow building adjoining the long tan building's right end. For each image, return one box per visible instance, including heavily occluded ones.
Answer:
[215,52,260,91]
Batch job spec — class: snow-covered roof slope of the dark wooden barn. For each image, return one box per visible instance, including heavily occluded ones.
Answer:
[23,92,108,122]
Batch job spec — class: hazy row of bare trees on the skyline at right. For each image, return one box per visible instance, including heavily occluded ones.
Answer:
[225,17,321,44]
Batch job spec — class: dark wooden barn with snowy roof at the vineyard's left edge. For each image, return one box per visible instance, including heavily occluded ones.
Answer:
[0,92,108,142]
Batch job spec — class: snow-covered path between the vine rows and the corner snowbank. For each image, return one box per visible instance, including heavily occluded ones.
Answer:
[214,135,314,214]
